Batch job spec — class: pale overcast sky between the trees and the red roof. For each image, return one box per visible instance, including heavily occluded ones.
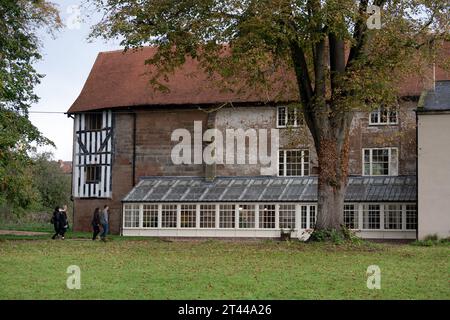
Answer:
[30,0,120,160]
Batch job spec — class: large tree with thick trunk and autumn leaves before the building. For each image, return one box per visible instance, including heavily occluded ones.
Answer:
[91,0,450,229]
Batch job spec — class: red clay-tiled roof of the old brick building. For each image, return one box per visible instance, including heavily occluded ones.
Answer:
[68,46,450,113]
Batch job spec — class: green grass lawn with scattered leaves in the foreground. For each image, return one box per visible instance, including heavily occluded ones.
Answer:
[0,234,450,299]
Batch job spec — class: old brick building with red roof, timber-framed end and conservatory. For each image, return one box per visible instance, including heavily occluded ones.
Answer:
[68,48,450,239]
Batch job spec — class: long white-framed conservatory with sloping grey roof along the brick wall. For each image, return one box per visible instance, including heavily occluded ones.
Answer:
[122,176,417,239]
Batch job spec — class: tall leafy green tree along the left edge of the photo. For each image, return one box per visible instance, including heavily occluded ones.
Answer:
[0,0,61,208]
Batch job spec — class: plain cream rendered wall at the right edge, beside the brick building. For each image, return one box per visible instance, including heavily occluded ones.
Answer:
[417,113,450,239]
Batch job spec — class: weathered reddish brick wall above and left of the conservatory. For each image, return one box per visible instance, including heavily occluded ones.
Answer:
[74,102,416,233]
